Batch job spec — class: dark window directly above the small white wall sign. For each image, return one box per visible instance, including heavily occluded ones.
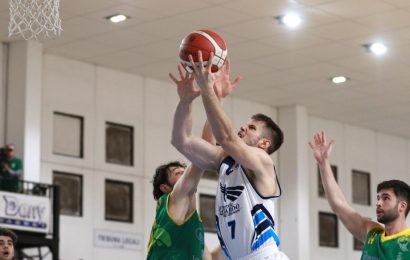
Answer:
[105,179,134,223]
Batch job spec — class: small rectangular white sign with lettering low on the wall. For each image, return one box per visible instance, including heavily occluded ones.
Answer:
[94,229,144,251]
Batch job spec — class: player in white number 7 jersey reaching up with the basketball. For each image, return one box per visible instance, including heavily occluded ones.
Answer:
[172,52,287,260]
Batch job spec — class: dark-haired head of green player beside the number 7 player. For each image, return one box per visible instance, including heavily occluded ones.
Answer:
[152,161,186,200]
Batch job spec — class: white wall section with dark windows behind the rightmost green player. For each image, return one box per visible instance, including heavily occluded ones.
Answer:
[309,117,410,260]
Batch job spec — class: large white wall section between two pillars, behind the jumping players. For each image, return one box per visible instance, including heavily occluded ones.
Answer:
[41,55,276,260]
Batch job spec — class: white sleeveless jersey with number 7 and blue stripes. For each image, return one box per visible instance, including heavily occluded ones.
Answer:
[215,157,287,259]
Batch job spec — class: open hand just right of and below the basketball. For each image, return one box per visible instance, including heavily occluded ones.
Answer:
[214,60,242,98]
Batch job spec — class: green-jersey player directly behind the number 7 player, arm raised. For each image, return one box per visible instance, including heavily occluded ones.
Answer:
[147,162,204,260]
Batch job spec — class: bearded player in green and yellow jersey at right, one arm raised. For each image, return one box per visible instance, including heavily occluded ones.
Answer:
[309,132,410,260]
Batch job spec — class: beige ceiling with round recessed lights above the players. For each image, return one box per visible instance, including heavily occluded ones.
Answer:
[0,0,410,138]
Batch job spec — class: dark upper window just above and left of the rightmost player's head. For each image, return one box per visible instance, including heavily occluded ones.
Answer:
[352,170,370,206]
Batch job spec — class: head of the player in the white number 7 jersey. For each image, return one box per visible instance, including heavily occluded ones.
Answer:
[238,114,283,154]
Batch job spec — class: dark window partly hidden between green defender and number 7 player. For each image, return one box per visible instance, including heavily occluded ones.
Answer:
[199,194,216,233]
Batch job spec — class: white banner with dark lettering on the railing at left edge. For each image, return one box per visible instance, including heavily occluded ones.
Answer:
[0,191,52,233]
